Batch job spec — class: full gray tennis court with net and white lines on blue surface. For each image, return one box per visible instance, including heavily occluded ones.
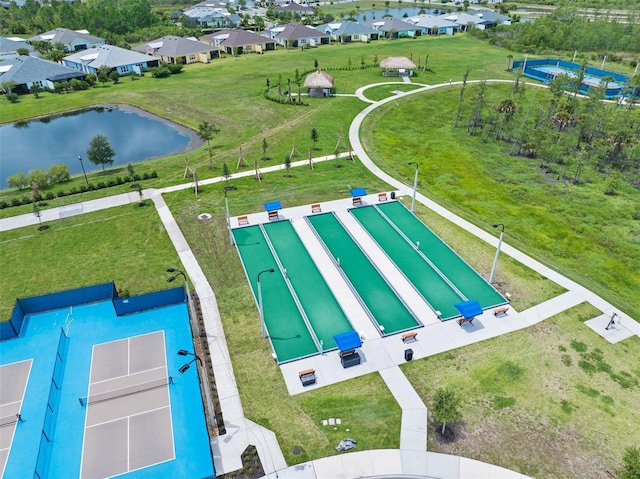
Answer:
[80,331,175,478]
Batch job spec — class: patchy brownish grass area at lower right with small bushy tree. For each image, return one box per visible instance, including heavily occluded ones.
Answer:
[402,304,640,479]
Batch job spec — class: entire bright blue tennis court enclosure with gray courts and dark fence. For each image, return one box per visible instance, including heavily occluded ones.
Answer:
[0,283,214,479]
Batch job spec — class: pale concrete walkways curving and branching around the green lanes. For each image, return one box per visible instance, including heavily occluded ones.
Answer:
[0,82,640,479]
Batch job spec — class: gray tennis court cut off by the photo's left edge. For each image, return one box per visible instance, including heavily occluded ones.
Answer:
[0,359,33,477]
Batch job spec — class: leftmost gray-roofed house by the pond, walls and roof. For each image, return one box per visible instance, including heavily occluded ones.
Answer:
[0,56,86,94]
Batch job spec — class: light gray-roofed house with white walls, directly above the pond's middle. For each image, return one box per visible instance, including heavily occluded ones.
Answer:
[62,45,160,75]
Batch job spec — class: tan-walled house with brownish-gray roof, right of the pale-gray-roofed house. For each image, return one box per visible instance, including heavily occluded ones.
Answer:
[133,35,220,65]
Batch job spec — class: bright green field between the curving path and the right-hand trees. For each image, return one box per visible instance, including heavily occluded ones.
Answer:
[362,86,640,324]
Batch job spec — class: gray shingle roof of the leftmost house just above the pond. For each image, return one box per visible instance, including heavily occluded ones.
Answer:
[0,56,85,85]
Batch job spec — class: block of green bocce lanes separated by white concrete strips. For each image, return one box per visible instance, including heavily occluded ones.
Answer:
[230,192,507,364]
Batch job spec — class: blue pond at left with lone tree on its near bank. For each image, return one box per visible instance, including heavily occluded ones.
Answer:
[0,105,201,188]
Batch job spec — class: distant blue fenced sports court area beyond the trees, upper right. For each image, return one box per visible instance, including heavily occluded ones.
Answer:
[512,58,631,98]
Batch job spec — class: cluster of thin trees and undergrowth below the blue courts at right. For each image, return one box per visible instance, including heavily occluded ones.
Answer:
[456,75,640,195]
